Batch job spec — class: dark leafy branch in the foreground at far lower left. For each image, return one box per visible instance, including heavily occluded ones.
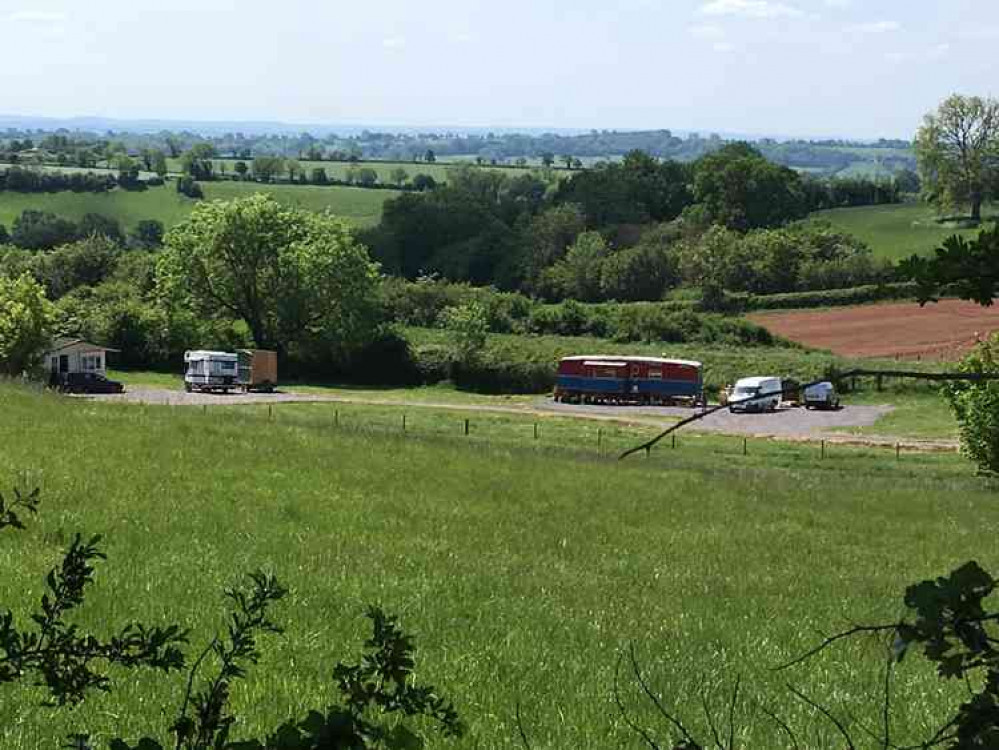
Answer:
[0,536,186,705]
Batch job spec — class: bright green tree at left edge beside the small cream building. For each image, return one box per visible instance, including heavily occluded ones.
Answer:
[0,274,53,376]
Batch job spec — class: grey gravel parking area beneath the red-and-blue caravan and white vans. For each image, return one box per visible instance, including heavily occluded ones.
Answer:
[538,399,893,437]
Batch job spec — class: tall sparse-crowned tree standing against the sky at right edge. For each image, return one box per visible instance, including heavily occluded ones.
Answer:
[916,94,999,221]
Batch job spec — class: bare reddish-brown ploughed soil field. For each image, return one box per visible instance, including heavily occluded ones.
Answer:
[749,300,999,360]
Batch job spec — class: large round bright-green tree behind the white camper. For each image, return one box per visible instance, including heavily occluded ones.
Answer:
[159,195,378,354]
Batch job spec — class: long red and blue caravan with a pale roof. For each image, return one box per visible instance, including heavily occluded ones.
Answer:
[555,355,704,406]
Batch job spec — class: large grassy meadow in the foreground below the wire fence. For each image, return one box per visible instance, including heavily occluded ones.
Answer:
[0,384,999,750]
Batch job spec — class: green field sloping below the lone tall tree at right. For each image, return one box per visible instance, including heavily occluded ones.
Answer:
[812,203,996,260]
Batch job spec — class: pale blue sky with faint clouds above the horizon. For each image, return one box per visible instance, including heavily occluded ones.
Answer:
[0,0,999,138]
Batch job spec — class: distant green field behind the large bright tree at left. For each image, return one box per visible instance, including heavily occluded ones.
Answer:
[0,182,398,229]
